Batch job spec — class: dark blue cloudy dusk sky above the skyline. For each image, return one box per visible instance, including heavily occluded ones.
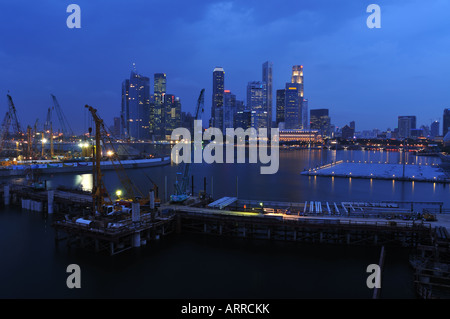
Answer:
[0,0,450,132]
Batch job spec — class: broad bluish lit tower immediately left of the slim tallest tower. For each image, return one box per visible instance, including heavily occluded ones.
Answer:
[247,81,268,129]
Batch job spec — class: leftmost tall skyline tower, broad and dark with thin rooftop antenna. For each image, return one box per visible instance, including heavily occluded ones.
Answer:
[122,69,150,140]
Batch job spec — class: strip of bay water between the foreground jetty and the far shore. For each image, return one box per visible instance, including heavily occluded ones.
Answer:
[8,149,450,207]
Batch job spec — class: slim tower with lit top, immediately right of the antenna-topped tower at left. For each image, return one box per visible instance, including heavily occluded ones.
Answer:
[150,73,167,139]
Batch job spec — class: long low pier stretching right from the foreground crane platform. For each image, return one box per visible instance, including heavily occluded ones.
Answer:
[161,201,433,247]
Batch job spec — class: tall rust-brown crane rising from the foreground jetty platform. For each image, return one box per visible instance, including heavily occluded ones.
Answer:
[85,105,146,213]
